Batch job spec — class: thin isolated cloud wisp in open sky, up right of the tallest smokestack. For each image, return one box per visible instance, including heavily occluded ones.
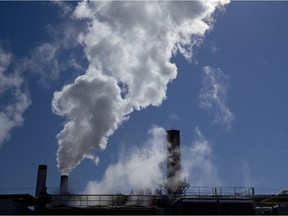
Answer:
[199,66,235,129]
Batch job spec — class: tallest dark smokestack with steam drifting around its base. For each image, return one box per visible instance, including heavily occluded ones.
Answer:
[167,130,182,195]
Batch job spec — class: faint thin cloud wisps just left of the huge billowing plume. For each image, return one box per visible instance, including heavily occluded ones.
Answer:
[25,22,84,88]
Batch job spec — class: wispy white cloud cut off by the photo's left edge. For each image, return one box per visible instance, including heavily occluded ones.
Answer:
[0,42,31,148]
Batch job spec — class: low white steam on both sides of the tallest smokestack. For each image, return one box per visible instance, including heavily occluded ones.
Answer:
[84,126,221,194]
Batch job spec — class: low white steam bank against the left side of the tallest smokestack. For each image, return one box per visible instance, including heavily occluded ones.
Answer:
[85,126,167,194]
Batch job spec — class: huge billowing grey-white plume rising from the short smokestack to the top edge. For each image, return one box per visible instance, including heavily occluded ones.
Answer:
[52,0,228,174]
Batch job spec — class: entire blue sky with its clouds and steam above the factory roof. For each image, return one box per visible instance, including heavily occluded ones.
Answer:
[0,1,288,194]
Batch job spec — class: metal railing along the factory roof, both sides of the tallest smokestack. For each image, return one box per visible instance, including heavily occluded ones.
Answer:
[50,186,254,208]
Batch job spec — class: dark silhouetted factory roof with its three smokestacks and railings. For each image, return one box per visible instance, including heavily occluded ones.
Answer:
[0,130,288,215]
